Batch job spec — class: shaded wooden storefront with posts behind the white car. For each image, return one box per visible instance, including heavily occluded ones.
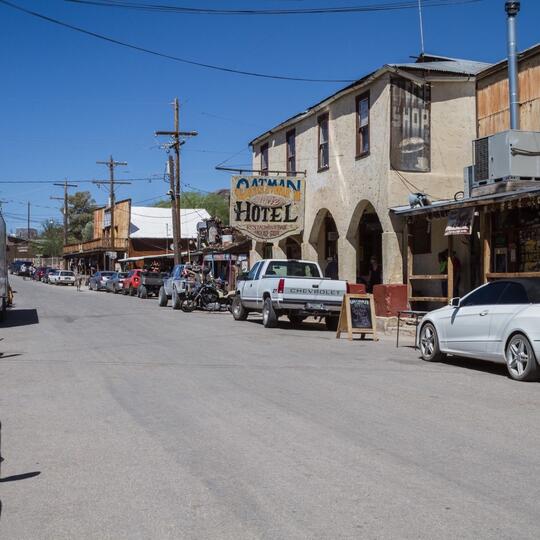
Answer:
[392,187,540,308]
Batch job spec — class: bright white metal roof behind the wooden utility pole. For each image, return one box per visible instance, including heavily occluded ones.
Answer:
[129,206,210,238]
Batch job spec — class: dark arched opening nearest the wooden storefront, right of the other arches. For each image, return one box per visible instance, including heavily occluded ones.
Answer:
[355,203,384,292]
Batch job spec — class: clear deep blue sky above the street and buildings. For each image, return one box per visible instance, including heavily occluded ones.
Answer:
[0,0,540,234]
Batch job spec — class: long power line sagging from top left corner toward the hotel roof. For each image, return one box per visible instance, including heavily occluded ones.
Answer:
[0,0,358,83]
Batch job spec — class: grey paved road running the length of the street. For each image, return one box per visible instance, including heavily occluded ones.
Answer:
[0,278,540,540]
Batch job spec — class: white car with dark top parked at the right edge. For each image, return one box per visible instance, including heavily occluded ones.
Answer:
[418,278,540,381]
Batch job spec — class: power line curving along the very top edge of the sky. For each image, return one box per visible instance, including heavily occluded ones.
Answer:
[65,0,483,16]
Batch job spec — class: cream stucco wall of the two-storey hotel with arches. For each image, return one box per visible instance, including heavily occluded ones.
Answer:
[253,74,475,283]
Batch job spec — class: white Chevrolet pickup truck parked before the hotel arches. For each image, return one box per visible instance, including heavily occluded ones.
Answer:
[231,259,347,330]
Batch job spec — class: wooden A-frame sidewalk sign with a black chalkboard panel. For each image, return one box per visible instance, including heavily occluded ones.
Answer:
[336,294,378,341]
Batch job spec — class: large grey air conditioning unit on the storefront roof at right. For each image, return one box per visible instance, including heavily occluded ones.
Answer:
[472,130,540,187]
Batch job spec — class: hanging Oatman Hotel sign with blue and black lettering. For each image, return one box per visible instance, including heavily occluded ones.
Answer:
[230,176,305,242]
